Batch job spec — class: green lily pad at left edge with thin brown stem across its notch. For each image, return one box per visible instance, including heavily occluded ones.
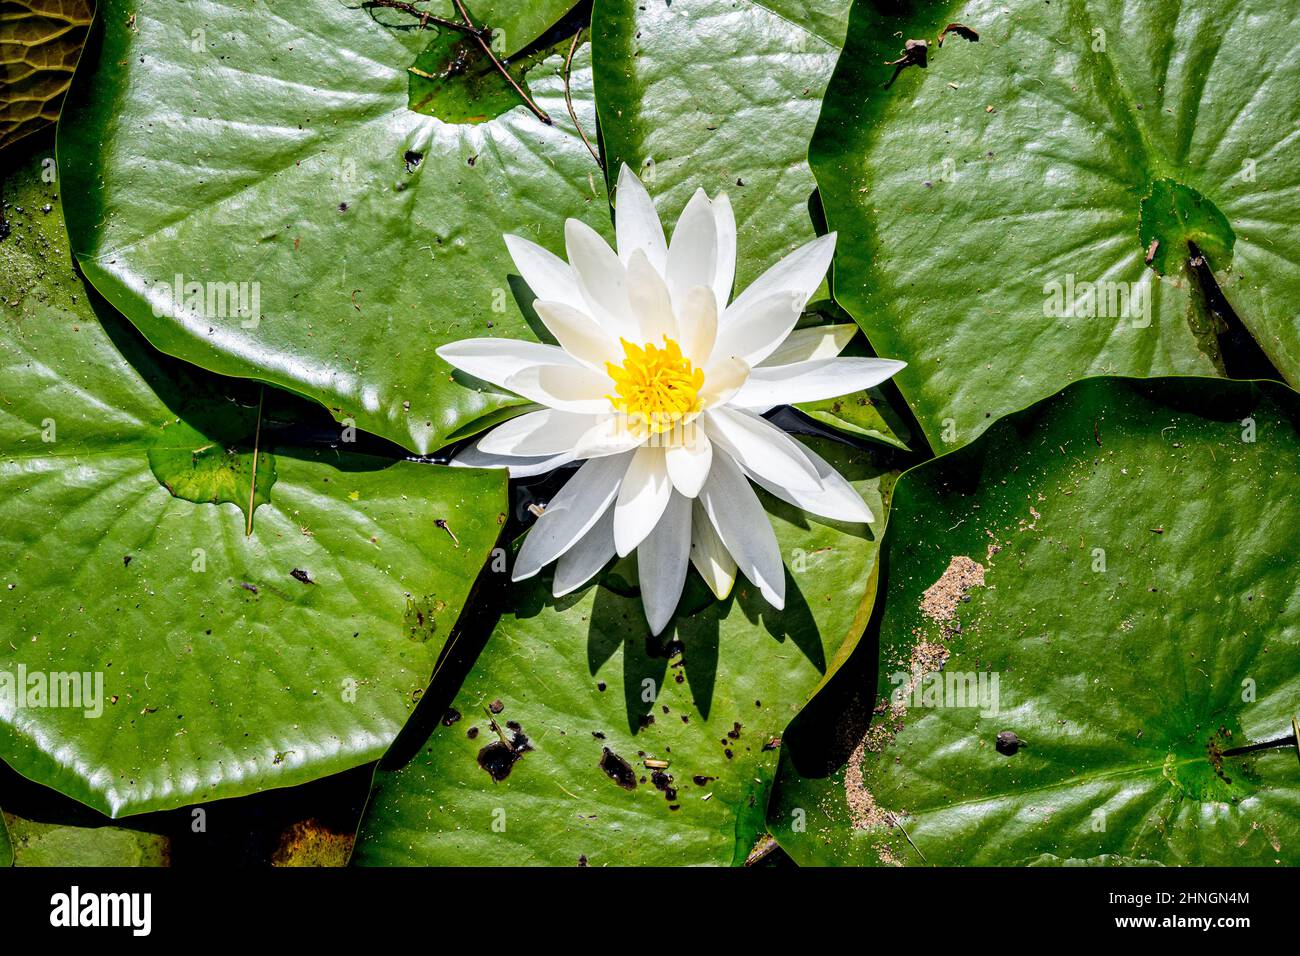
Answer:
[0,145,506,816]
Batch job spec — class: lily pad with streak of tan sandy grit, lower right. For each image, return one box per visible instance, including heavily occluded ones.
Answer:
[768,378,1300,866]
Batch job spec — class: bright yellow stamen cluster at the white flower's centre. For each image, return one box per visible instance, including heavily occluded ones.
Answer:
[605,336,705,433]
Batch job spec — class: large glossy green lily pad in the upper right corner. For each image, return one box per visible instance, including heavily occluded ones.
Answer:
[810,0,1300,450]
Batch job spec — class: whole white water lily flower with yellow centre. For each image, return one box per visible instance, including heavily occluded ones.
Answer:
[438,166,905,633]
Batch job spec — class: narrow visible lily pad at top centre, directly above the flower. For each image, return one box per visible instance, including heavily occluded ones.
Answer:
[592,0,849,290]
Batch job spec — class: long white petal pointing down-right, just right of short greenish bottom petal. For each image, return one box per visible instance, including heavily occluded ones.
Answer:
[699,453,785,609]
